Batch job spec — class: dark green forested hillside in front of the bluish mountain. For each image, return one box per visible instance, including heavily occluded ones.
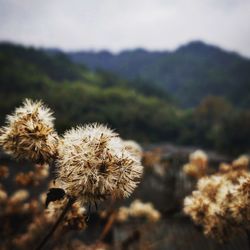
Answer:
[0,44,250,154]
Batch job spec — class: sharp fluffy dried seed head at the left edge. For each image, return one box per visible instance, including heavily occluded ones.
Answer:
[0,99,58,163]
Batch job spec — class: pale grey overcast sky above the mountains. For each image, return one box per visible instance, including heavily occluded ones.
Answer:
[0,0,250,57]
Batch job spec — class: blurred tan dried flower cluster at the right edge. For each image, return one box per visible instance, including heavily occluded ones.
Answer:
[184,160,250,242]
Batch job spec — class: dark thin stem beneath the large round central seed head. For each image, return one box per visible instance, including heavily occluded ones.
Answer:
[35,197,75,250]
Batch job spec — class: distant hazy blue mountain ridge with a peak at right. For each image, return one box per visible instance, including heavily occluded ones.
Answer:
[68,41,250,108]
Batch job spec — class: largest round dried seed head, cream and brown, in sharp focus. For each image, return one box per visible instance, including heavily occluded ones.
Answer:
[57,124,142,202]
